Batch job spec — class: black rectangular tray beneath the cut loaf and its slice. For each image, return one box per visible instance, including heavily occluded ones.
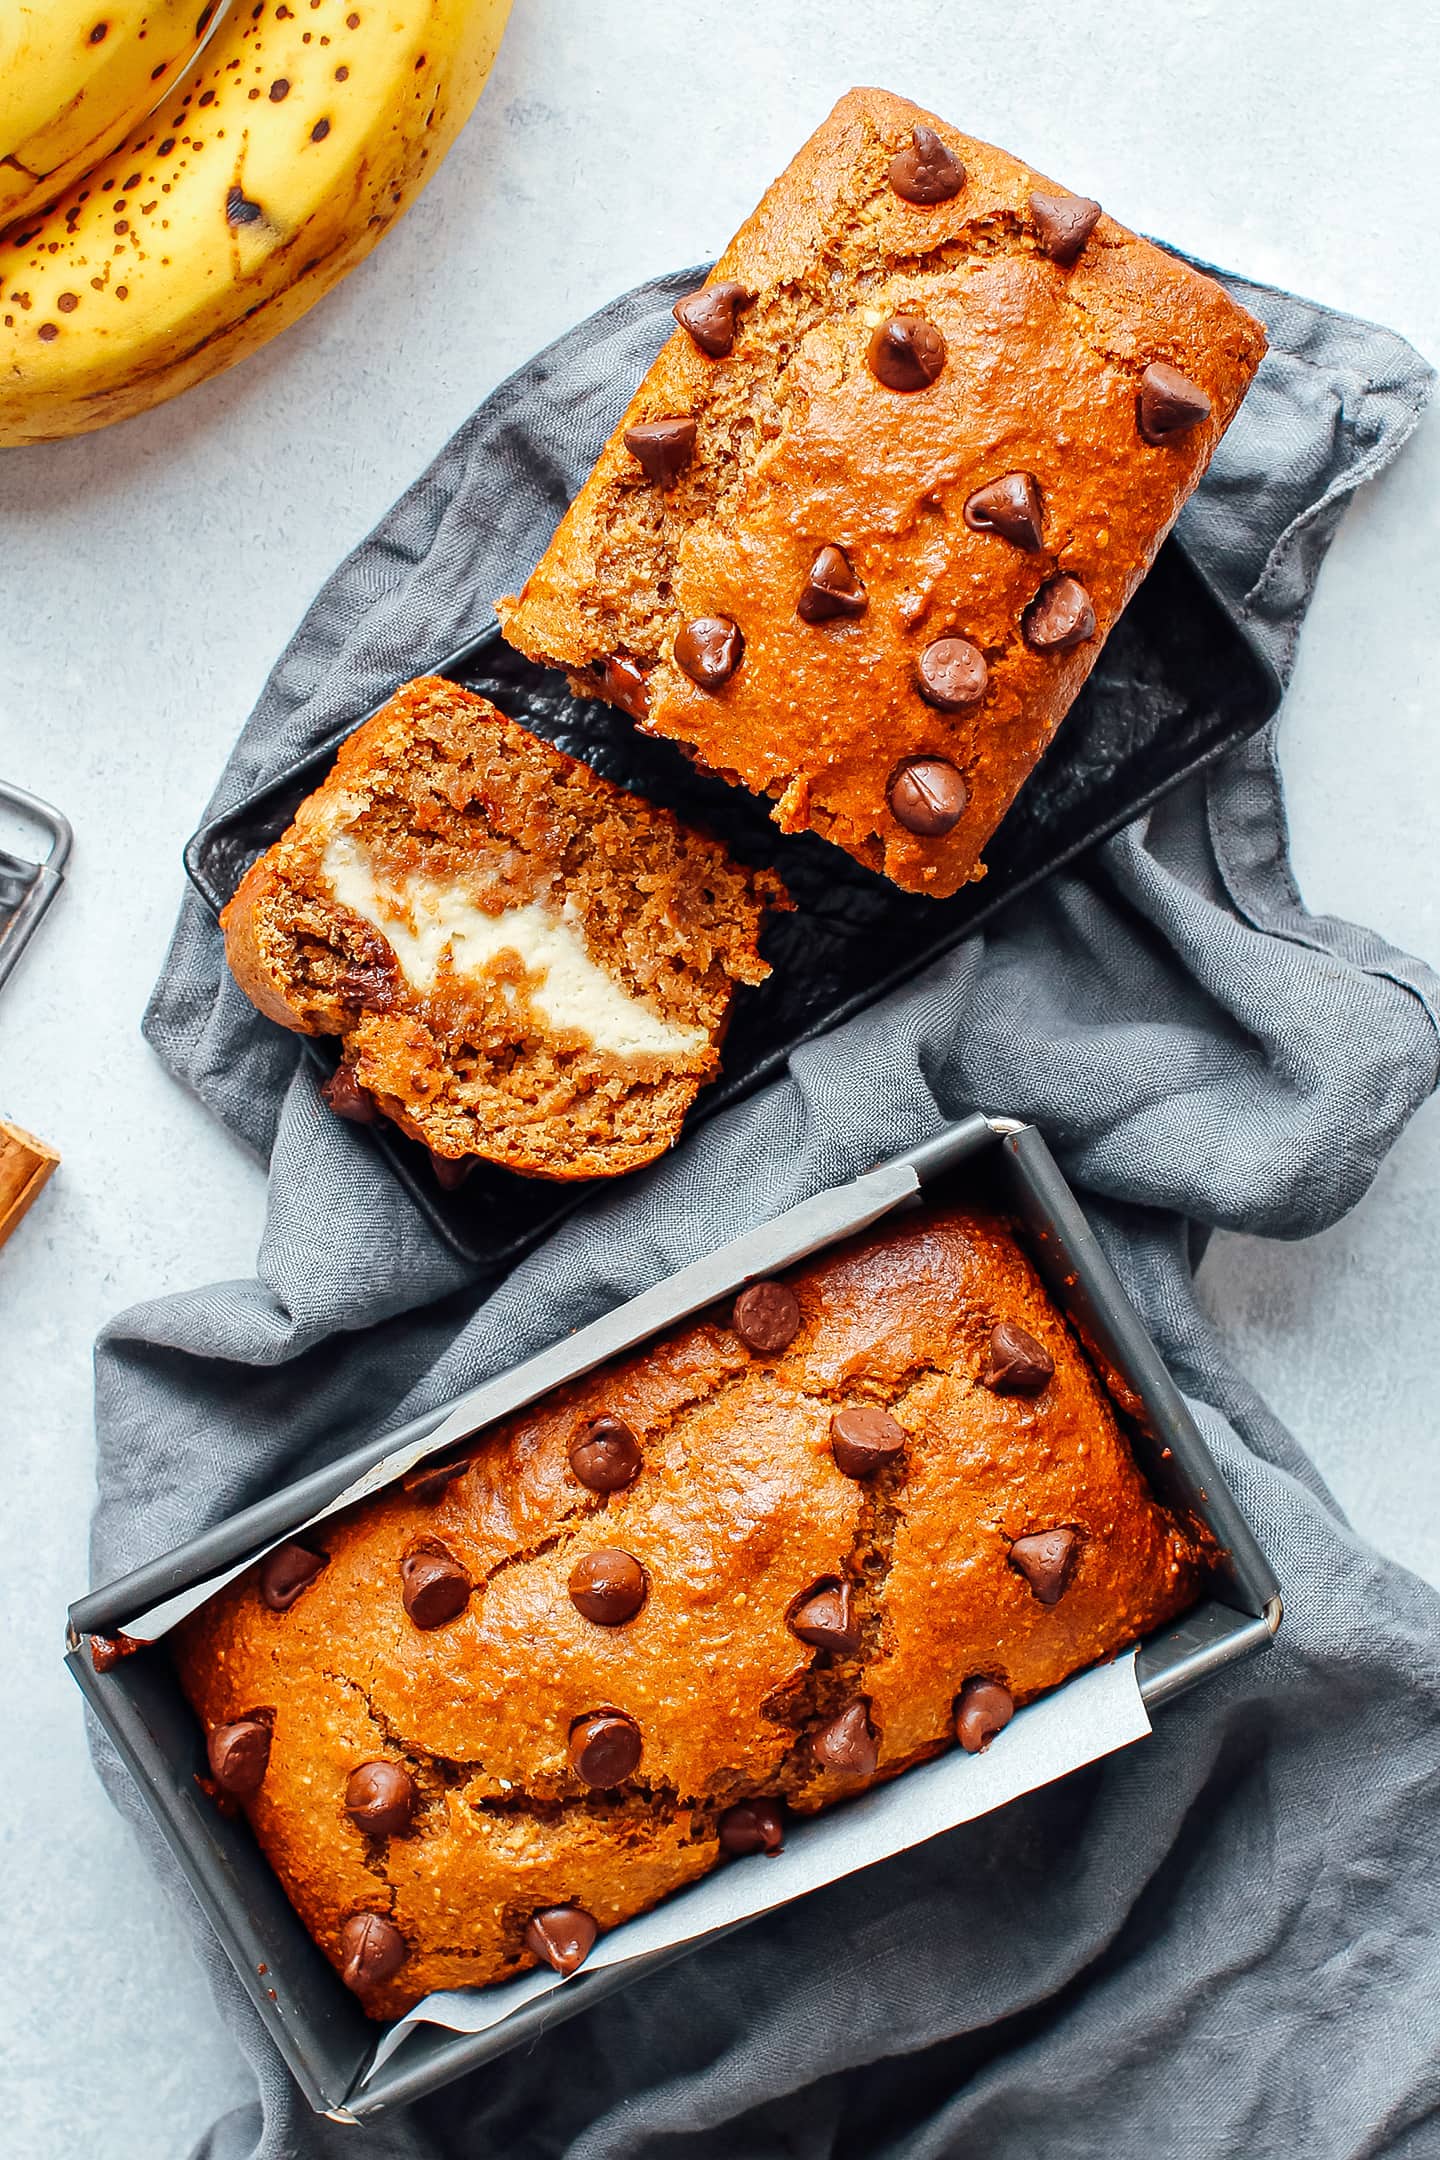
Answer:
[186,540,1280,1277]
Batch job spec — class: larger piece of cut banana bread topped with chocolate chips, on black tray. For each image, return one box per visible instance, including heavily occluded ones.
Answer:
[499,91,1265,894]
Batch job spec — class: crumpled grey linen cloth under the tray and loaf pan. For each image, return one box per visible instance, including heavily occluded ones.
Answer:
[93,272,1440,2160]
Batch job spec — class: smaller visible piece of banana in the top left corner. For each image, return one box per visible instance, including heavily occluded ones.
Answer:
[0,0,220,227]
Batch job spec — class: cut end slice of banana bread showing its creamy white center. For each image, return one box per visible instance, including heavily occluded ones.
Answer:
[220,676,786,1179]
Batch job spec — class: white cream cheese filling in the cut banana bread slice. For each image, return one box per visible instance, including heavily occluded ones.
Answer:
[320,832,708,1058]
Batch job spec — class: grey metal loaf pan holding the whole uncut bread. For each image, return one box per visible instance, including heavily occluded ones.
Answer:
[65,1115,1280,2121]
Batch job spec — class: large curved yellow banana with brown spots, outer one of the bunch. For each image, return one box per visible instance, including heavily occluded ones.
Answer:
[0,0,510,445]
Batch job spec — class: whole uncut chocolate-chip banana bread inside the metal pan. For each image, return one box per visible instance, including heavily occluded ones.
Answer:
[177,1212,1205,2017]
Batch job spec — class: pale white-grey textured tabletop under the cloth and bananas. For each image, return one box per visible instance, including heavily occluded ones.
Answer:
[0,0,1440,2160]
